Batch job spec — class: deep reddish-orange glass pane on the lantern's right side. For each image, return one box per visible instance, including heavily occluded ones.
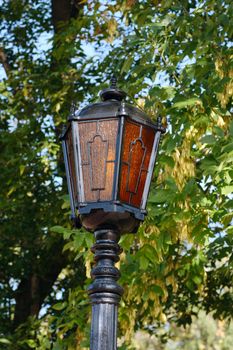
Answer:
[119,120,155,207]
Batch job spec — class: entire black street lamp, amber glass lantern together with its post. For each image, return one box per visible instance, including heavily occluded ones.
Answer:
[62,79,165,350]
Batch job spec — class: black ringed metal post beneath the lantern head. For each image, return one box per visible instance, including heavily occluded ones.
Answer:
[88,229,123,350]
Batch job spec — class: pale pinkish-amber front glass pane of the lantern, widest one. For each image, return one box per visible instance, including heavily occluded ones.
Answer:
[79,119,118,202]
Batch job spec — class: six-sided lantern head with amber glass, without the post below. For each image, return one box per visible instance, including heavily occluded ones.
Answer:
[62,82,164,233]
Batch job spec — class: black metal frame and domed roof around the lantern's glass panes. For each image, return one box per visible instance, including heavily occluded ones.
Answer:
[62,100,165,221]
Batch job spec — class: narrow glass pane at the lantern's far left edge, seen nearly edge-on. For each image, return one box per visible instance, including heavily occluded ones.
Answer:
[66,127,78,201]
